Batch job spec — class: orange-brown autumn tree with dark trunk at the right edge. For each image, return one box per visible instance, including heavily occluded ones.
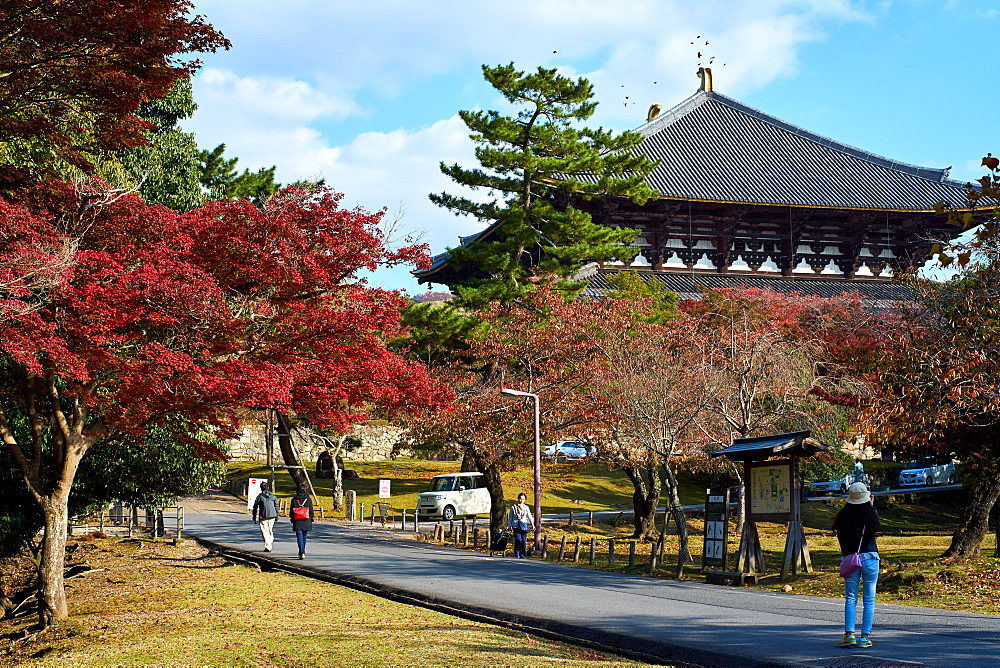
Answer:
[861,236,1000,557]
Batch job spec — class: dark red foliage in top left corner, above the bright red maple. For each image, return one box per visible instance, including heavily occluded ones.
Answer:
[0,0,229,183]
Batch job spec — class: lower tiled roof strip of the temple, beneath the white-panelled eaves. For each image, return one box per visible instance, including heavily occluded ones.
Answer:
[583,270,913,308]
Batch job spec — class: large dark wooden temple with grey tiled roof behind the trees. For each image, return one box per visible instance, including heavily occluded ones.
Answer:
[414,70,966,303]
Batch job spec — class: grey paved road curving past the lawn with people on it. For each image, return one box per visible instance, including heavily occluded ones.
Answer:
[185,490,1000,668]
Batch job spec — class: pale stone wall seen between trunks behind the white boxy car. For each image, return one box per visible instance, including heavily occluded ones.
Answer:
[228,423,409,462]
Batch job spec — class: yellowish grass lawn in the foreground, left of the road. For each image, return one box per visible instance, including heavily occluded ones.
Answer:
[0,537,641,667]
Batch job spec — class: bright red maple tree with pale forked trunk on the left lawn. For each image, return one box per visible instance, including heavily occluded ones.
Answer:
[0,183,448,626]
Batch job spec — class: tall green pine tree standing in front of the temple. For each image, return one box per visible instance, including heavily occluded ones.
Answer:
[430,63,655,306]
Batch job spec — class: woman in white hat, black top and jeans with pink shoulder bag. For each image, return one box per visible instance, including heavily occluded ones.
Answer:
[833,482,882,647]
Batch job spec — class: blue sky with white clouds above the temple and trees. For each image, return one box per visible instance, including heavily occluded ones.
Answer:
[185,0,1000,294]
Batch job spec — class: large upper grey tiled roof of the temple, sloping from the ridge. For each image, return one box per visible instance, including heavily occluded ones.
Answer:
[636,91,966,211]
